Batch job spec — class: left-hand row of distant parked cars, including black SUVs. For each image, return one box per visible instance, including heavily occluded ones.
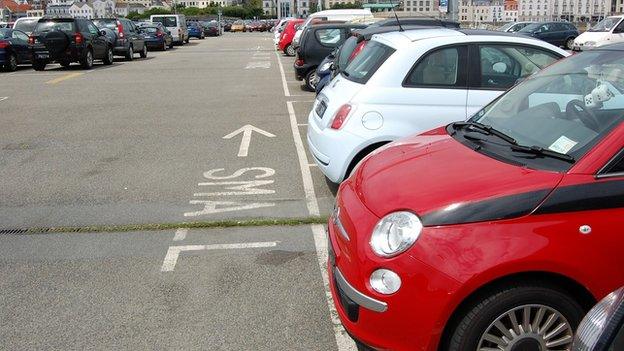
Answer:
[0,14,221,71]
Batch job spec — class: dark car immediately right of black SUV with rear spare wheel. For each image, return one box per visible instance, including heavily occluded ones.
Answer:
[93,18,147,61]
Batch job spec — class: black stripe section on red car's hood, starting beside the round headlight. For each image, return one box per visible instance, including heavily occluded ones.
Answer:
[421,189,550,226]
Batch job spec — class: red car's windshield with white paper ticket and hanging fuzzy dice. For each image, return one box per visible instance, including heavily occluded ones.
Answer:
[471,51,624,170]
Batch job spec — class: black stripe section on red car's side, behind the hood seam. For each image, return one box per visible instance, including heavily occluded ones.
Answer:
[535,180,624,214]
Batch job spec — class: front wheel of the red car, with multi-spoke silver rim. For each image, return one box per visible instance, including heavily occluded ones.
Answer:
[441,281,585,351]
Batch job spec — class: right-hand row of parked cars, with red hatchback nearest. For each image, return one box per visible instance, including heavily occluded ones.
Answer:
[275,11,624,351]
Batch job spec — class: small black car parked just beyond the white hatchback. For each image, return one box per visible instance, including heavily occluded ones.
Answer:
[294,23,366,91]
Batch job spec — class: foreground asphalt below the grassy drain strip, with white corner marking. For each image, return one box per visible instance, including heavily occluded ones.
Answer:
[0,227,336,350]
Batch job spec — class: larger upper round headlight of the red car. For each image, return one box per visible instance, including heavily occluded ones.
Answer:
[370,211,423,257]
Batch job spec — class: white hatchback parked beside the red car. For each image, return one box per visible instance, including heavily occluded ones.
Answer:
[308,28,569,183]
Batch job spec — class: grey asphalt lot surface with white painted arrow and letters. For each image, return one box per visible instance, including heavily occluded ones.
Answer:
[0,33,353,350]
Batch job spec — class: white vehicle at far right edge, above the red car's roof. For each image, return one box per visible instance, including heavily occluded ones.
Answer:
[572,15,624,51]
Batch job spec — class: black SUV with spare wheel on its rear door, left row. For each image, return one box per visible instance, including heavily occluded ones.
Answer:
[28,17,113,71]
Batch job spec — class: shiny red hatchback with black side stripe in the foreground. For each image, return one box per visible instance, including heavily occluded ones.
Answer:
[328,44,624,351]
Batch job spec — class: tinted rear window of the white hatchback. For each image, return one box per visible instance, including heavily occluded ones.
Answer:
[342,41,395,84]
